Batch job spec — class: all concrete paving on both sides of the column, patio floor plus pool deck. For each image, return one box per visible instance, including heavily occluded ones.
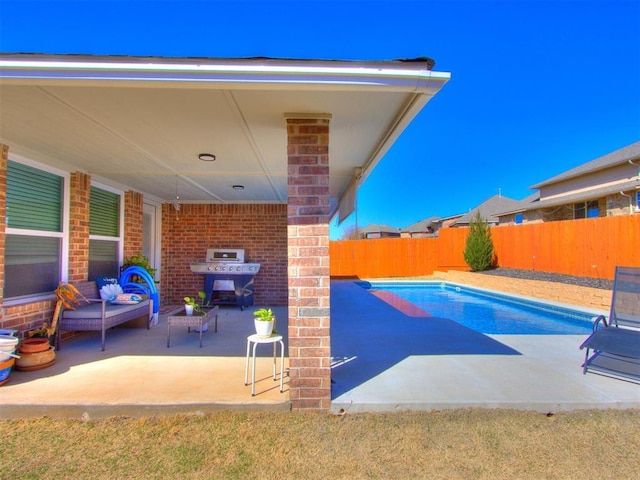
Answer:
[0,280,640,419]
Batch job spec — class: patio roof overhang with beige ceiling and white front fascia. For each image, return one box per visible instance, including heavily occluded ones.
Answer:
[0,54,449,214]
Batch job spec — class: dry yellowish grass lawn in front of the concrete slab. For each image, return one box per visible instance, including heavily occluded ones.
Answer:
[0,409,640,480]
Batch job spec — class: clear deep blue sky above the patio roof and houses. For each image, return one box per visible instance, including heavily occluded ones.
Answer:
[0,0,640,238]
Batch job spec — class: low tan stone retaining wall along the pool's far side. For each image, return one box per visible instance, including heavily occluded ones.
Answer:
[433,270,612,311]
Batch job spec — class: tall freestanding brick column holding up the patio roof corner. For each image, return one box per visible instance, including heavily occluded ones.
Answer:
[287,115,331,410]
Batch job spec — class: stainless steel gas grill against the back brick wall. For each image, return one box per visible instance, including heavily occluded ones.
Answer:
[191,248,260,310]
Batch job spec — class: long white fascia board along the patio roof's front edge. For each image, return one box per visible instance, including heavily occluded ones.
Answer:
[0,57,450,93]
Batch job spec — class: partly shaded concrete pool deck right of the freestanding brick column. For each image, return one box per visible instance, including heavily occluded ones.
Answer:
[331,281,640,413]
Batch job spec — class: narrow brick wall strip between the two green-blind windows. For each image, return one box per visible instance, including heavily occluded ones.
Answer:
[69,172,91,282]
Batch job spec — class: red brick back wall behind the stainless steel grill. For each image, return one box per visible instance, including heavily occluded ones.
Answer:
[160,204,287,305]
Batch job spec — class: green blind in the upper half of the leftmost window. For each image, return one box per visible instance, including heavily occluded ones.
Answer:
[7,160,64,232]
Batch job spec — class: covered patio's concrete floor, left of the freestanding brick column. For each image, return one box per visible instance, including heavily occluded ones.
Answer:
[0,307,290,419]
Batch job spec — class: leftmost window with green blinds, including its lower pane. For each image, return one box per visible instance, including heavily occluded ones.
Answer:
[3,160,64,298]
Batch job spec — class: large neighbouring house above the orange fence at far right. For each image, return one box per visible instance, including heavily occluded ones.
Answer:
[498,142,640,225]
